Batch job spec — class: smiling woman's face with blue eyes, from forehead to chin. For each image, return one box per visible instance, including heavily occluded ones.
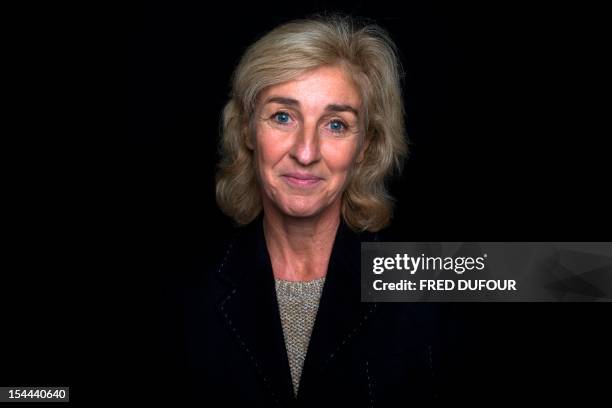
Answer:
[249,66,364,217]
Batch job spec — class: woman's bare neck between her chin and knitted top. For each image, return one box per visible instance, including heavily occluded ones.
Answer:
[263,199,340,281]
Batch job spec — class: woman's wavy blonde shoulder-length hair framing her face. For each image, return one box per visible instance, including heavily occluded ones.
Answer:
[216,15,408,231]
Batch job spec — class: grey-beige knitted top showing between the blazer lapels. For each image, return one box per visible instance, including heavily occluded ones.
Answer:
[275,277,325,396]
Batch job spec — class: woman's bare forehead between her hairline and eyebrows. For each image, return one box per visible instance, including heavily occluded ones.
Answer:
[260,66,361,108]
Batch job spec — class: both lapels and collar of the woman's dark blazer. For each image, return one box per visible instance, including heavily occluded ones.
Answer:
[218,216,376,406]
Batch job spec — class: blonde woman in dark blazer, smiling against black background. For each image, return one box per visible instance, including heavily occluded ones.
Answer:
[165,16,466,407]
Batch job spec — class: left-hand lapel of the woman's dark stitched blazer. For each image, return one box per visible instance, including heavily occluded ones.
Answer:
[219,219,294,407]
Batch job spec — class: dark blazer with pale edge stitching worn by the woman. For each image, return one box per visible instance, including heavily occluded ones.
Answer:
[158,217,474,407]
